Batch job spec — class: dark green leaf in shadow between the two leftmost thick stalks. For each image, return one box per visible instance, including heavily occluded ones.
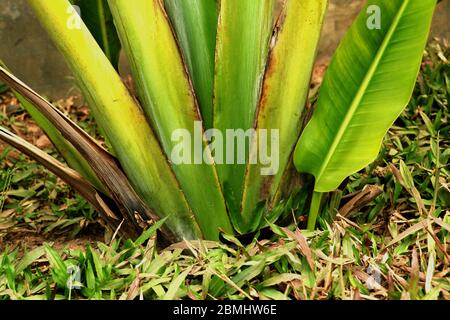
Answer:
[70,0,121,70]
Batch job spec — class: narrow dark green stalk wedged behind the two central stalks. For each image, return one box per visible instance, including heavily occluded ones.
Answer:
[164,0,218,129]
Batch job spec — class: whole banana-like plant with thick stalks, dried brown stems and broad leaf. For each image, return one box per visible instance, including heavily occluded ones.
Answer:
[0,0,436,241]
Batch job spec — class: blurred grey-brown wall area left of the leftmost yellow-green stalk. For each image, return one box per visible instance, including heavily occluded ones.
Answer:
[0,0,75,98]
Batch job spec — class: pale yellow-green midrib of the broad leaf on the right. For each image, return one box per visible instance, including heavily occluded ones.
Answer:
[315,0,410,191]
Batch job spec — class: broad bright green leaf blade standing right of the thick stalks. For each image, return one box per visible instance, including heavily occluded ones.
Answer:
[295,0,436,192]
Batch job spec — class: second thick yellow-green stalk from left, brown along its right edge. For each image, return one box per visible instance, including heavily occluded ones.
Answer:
[109,0,232,239]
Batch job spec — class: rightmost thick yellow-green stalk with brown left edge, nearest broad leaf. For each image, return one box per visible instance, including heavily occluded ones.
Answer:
[242,0,328,229]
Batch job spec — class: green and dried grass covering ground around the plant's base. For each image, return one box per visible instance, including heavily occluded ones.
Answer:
[0,41,450,300]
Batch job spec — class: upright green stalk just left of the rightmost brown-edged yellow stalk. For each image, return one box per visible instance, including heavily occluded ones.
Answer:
[214,0,276,232]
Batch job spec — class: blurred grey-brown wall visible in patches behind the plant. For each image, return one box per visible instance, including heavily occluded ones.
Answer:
[0,0,450,99]
